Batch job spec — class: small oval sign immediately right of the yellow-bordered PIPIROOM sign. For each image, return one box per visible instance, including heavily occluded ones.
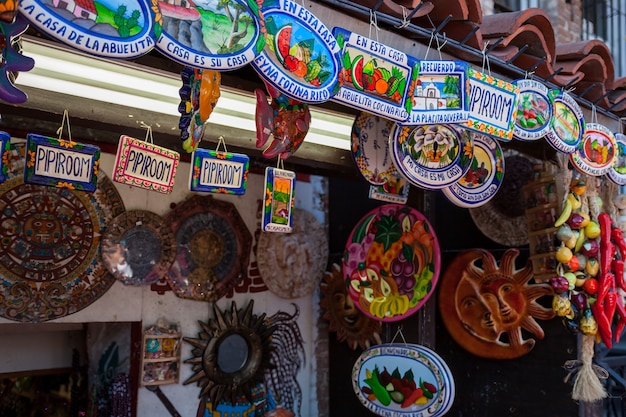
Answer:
[513,79,552,141]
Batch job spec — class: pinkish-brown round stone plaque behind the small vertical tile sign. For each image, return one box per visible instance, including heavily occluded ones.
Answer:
[256,208,328,298]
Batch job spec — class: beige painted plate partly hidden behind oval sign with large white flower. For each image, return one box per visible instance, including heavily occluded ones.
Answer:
[350,112,398,185]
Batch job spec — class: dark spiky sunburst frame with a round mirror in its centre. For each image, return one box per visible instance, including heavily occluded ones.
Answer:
[183,300,274,406]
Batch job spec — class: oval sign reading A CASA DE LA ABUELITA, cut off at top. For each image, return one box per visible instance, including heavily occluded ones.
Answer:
[19,0,156,59]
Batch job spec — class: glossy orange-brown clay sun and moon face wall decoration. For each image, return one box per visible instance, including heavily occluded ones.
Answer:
[439,249,554,359]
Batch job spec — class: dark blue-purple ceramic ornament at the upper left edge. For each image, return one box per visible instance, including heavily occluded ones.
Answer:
[0,14,35,104]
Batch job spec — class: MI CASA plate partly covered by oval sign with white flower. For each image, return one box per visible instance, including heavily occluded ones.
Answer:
[441,133,504,208]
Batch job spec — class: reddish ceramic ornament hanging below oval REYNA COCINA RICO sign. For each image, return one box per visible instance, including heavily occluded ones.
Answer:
[254,81,311,160]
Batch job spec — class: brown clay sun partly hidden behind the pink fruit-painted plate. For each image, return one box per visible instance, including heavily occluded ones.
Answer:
[320,264,382,350]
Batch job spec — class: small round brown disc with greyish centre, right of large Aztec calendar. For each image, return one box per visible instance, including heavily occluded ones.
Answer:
[100,210,176,285]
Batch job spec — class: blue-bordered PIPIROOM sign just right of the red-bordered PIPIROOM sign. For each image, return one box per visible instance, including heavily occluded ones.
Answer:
[189,148,250,195]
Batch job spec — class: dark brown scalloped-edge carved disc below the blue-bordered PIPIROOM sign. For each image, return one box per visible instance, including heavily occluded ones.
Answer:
[165,195,252,302]
